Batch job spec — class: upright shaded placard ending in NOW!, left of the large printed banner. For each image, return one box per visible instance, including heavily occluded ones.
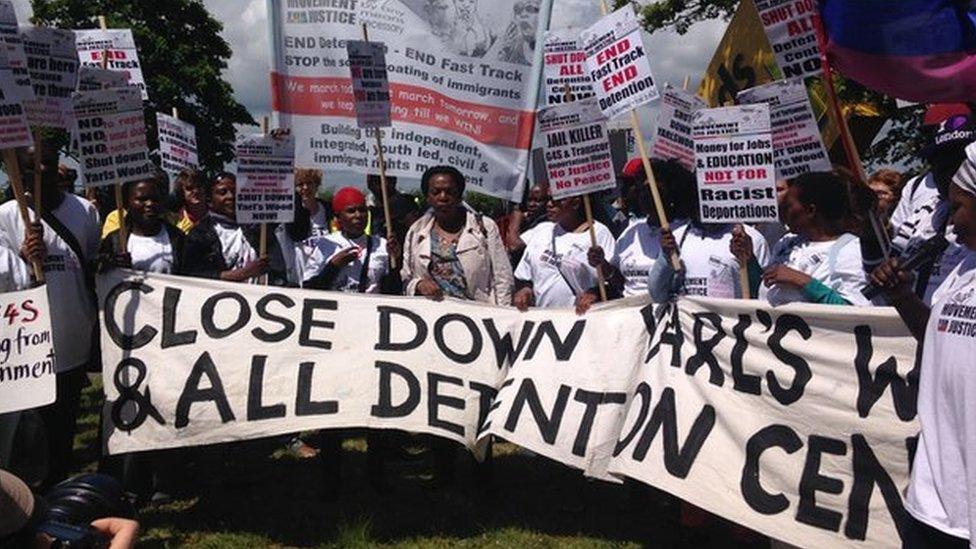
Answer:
[236,133,295,223]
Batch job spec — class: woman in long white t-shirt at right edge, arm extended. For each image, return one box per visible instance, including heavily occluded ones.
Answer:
[871,143,976,549]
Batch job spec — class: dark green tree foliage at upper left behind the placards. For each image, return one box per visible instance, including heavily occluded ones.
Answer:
[31,0,255,170]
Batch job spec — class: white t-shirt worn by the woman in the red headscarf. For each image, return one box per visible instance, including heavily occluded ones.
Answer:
[304,232,390,294]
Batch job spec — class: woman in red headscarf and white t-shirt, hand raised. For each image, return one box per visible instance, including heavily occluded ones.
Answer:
[303,187,399,294]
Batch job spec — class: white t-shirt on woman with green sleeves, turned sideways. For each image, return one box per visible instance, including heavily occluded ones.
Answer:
[759,233,871,307]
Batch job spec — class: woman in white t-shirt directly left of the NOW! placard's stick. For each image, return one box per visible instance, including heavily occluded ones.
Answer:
[182,172,269,282]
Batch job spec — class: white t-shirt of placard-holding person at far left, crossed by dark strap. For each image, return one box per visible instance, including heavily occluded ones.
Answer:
[0,193,101,372]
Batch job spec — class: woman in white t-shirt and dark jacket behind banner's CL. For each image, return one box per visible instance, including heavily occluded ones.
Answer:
[98,172,185,274]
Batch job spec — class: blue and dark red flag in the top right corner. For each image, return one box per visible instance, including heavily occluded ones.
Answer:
[820,0,976,102]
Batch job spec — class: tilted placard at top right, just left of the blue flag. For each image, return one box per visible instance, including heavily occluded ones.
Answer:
[755,0,821,78]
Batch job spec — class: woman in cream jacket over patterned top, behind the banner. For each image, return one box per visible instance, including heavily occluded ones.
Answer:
[401,166,515,305]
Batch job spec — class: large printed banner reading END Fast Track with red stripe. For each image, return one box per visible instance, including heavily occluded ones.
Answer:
[268,0,551,201]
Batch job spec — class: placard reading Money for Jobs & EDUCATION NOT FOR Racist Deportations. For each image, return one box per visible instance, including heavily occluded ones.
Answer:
[692,103,778,223]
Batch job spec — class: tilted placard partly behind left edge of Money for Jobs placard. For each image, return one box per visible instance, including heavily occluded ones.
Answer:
[651,84,706,171]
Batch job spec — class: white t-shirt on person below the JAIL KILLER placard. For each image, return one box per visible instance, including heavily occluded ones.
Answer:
[515,221,616,308]
